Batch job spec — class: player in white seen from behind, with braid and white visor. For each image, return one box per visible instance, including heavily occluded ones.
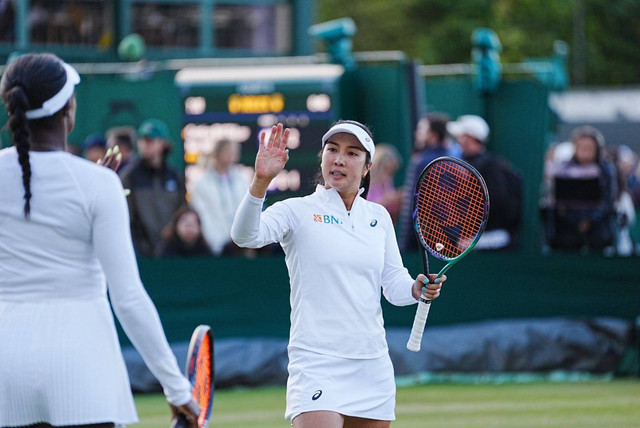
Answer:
[0,54,198,428]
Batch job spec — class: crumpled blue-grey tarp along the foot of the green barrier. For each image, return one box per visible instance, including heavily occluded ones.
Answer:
[123,318,633,392]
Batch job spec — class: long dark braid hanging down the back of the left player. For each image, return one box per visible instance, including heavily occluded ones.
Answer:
[5,85,31,217]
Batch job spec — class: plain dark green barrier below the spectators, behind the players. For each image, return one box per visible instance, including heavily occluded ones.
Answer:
[123,253,640,341]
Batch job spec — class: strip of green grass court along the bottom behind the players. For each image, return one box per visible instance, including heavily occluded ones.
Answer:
[136,379,640,428]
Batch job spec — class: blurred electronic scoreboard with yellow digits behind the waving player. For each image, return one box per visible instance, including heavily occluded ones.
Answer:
[176,64,344,203]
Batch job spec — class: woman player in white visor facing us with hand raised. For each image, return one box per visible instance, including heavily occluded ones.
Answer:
[231,121,446,428]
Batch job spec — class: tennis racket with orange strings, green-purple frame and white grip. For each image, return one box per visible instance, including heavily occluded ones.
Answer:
[407,156,489,352]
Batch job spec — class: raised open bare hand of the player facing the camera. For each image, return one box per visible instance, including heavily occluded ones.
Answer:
[249,123,290,198]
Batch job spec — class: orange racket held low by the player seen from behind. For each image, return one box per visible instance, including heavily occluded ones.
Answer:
[171,325,214,428]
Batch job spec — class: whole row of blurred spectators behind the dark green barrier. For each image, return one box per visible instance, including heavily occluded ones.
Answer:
[67,113,640,257]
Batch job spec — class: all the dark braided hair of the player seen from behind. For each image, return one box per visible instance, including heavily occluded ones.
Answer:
[0,54,67,218]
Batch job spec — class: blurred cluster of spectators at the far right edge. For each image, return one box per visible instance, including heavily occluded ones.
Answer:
[540,126,640,256]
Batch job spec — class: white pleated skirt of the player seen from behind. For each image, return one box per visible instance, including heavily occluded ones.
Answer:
[0,297,138,427]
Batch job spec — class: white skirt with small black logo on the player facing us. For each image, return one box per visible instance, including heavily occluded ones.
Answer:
[285,347,396,421]
